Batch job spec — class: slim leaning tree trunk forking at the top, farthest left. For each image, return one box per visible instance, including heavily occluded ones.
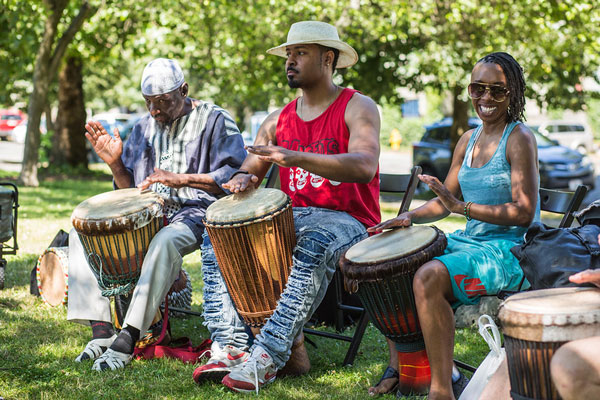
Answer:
[19,0,96,186]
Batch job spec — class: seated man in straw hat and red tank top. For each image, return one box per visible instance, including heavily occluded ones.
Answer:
[194,21,381,392]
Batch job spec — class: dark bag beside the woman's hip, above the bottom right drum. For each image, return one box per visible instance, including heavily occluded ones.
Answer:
[510,222,600,289]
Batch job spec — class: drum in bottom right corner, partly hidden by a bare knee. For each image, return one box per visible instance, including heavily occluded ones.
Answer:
[498,287,600,400]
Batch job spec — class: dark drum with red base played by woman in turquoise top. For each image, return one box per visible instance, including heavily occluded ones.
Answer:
[340,226,447,394]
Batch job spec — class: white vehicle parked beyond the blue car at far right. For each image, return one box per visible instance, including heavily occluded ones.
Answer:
[534,121,594,154]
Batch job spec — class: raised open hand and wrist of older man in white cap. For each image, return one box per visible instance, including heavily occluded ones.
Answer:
[85,121,132,189]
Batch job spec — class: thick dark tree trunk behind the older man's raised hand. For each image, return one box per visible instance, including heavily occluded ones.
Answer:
[50,54,87,168]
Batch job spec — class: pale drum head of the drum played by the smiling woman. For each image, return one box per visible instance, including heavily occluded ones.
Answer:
[345,225,438,264]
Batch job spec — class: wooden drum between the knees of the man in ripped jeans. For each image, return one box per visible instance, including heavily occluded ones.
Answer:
[204,189,296,328]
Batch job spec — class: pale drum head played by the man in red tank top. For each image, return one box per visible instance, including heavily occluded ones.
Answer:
[206,188,289,224]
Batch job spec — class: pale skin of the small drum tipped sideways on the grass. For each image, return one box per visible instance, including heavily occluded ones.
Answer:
[35,247,69,307]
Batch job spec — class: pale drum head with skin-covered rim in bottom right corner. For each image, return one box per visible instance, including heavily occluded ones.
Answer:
[498,287,600,342]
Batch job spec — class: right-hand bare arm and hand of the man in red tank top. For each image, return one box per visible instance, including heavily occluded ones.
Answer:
[248,93,380,183]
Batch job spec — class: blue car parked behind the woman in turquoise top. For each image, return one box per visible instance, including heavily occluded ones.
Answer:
[413,118,595,190]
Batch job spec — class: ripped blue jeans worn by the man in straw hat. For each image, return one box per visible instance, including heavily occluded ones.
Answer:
[202,207,367,368]
